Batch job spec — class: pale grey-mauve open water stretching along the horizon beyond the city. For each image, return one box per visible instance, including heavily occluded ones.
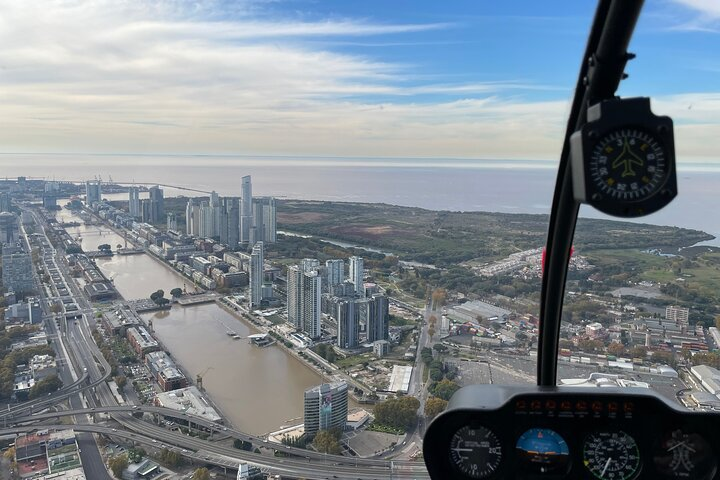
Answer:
[0,154,720,245]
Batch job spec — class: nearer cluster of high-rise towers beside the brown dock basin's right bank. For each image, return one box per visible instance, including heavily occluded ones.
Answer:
[287,257,389,348]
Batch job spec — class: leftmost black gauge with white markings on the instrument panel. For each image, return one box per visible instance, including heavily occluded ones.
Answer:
[450,426,502,478]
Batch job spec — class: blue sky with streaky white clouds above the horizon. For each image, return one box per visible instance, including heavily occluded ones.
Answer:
[0,0,720,162]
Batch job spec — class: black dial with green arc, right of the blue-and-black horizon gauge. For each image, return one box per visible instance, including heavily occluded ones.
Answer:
[583,431,640,480]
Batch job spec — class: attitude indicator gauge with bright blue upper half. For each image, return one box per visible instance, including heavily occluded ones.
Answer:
[515,428,570,473]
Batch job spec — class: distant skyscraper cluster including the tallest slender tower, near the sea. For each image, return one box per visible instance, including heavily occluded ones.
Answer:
[185,176,277,249]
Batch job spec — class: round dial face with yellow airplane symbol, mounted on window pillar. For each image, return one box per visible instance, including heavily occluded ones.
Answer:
[589,128,668,202]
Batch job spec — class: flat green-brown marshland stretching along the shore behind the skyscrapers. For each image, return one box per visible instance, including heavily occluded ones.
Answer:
[277,200,711,267]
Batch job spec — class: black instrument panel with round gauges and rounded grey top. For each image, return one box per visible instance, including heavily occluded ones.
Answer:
[423,385,720,480]
